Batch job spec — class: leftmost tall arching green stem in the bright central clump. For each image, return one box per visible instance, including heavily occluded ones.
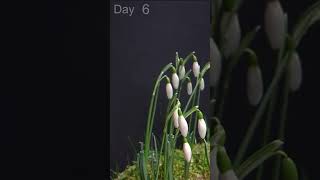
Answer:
[144,63,173,160]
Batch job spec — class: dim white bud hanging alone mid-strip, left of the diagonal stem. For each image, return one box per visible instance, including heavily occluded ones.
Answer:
[247,66,263,106]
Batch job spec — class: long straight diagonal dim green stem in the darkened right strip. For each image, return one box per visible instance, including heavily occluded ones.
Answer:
[234,49,293,167]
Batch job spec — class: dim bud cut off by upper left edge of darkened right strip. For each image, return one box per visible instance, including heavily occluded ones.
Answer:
[210,38,222,87]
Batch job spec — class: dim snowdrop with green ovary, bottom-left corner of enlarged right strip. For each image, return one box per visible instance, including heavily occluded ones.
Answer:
[217,146,238,180]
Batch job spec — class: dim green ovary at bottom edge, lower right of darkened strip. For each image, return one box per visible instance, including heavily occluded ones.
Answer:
[281,157,299,180]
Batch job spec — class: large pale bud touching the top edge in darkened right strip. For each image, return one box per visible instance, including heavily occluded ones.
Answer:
[264,0,285,49]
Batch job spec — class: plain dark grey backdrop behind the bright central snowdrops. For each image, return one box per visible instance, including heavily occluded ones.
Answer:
[110,1,210,169]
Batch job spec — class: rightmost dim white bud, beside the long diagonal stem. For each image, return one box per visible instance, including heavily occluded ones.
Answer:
[289,52,302,92]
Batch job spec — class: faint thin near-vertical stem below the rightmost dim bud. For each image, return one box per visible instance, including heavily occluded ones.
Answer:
[272,69,289,180]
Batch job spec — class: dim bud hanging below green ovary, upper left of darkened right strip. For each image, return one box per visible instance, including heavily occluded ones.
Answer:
[220,11,241,58]
